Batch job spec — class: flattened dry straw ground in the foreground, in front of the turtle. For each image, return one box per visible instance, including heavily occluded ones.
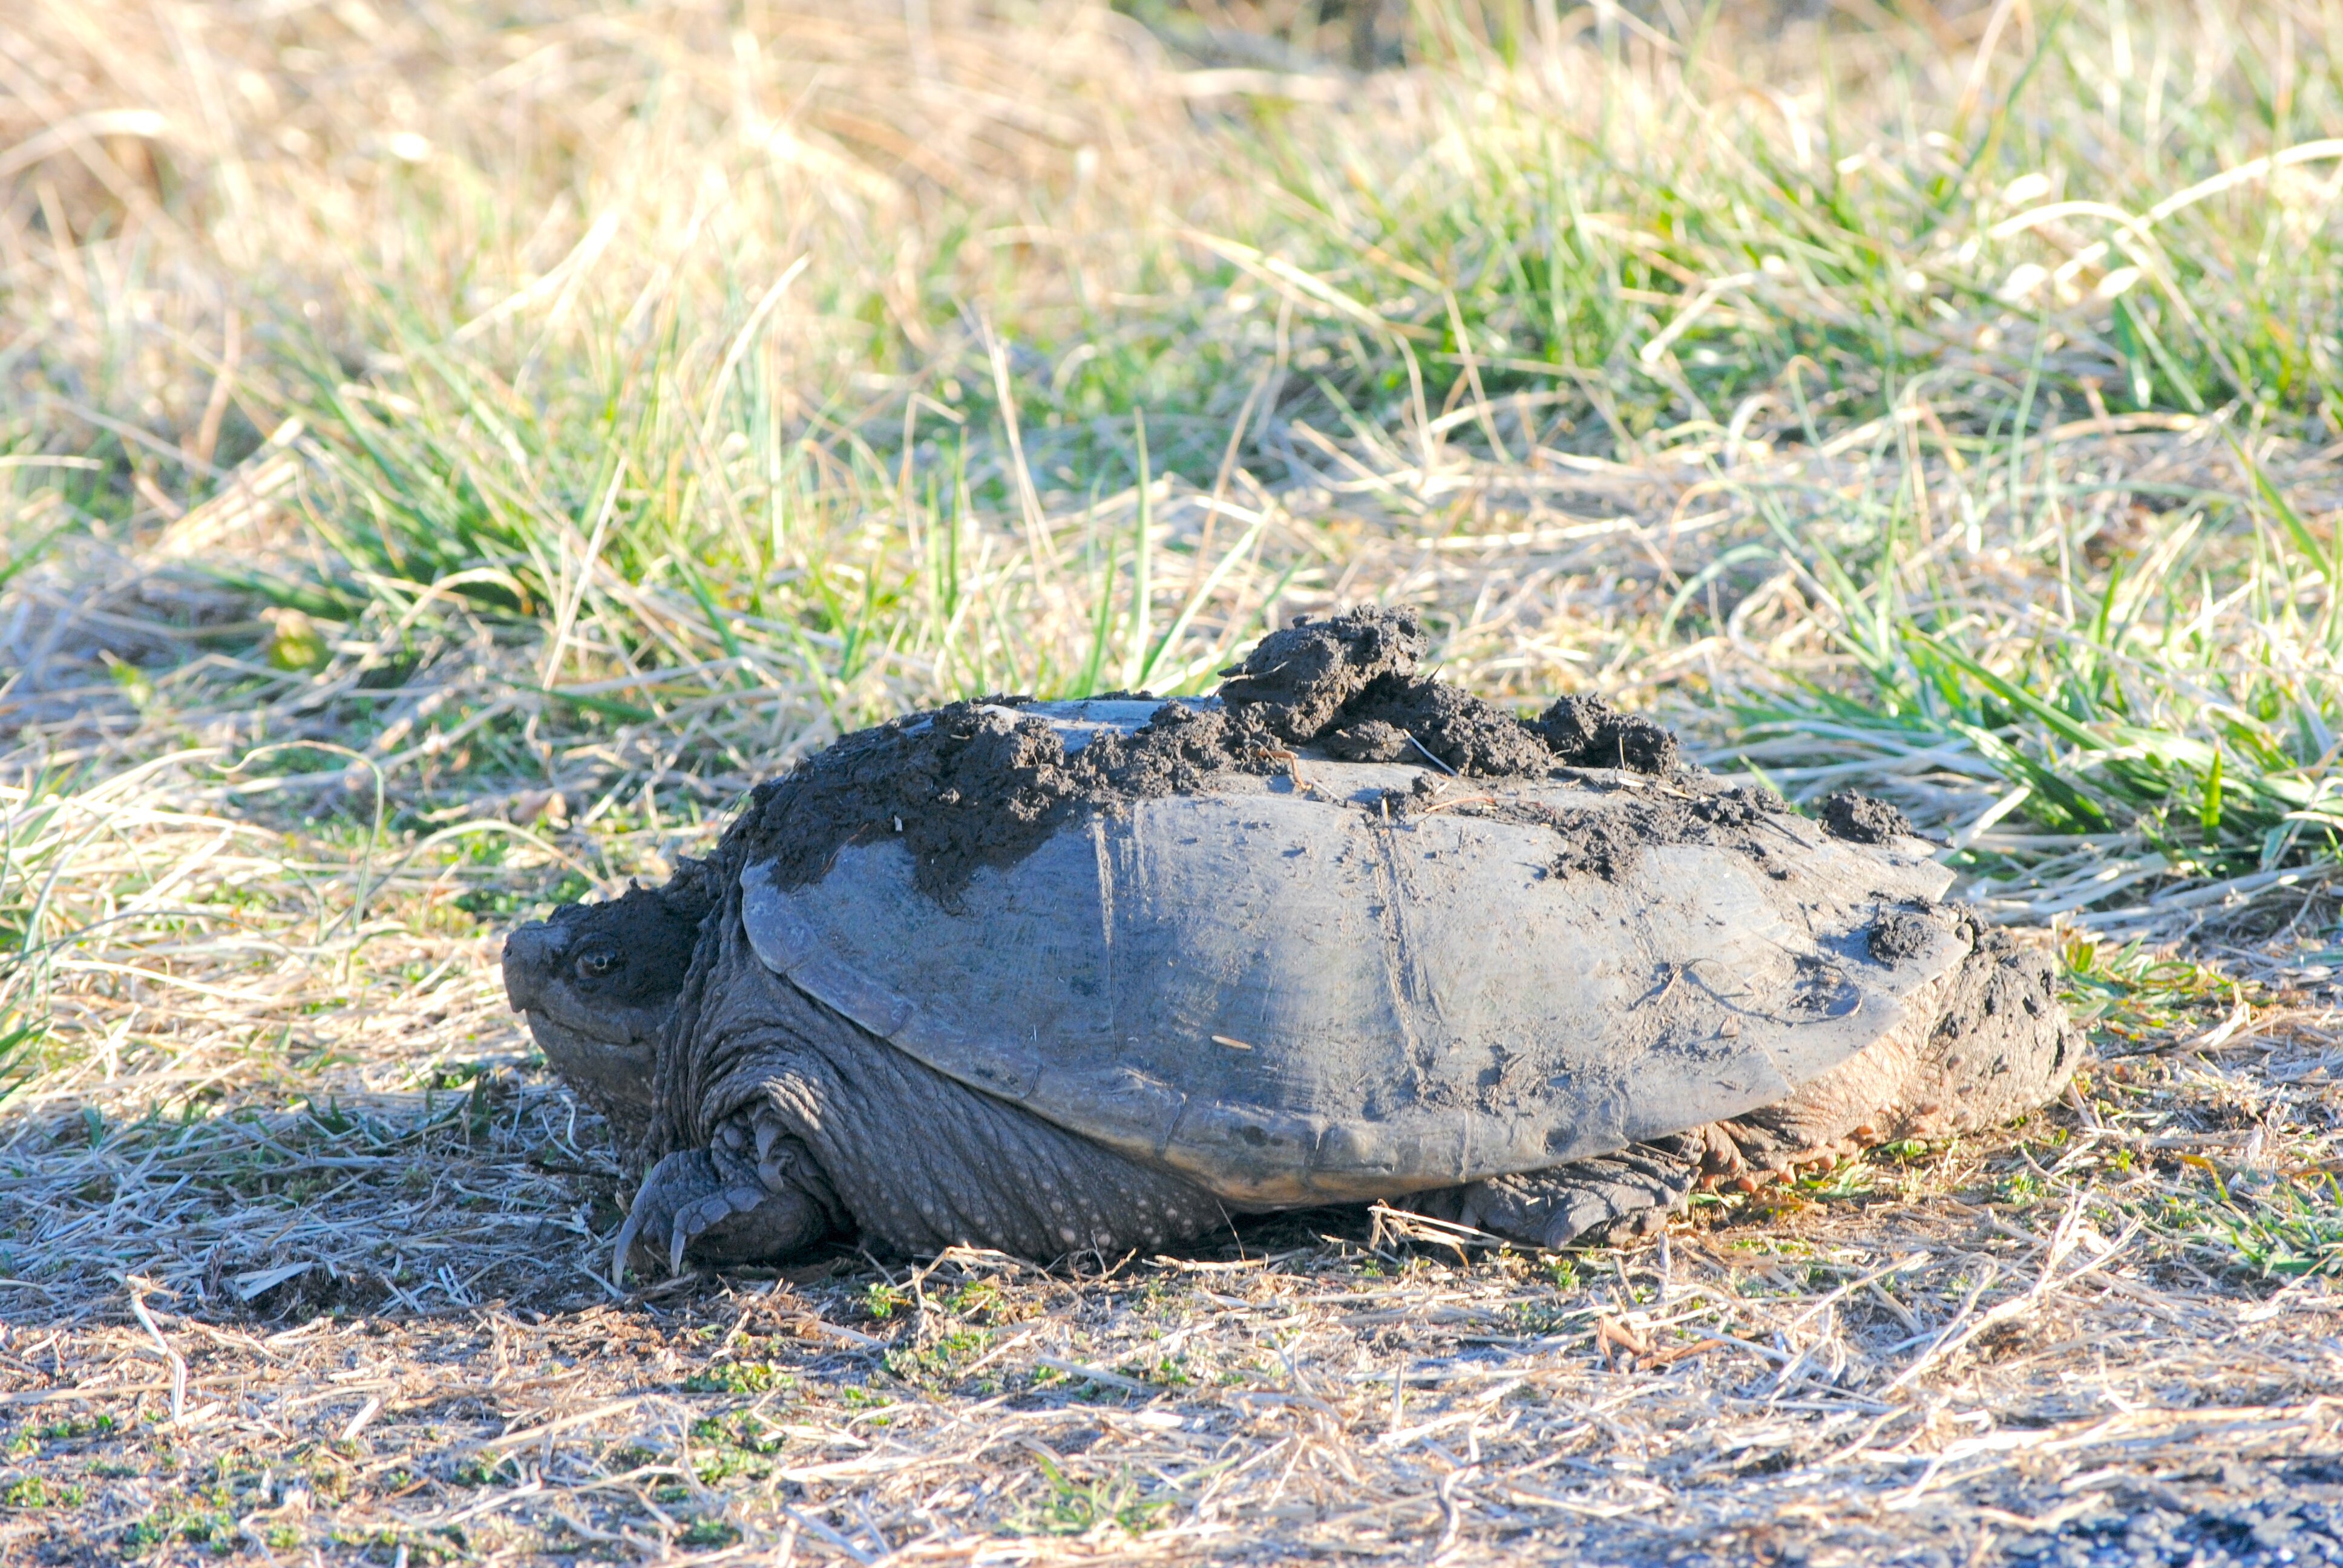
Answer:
[0,998,2343,1563]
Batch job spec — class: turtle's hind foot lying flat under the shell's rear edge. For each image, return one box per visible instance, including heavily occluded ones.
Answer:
[1401,1139,1701,1247]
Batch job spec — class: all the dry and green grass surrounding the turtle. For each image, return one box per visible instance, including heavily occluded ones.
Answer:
[0,0,2343,1568]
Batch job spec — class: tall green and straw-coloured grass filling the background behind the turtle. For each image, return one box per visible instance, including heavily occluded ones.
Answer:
[0,0,2343,956]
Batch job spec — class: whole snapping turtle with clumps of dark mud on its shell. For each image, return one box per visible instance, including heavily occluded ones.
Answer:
[503,609,2076,1270]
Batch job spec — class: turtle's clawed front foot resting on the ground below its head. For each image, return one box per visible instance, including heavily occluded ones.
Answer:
[614,1118,844,1275]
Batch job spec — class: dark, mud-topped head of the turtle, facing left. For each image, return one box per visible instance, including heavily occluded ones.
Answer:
[503,888,705,1142]
